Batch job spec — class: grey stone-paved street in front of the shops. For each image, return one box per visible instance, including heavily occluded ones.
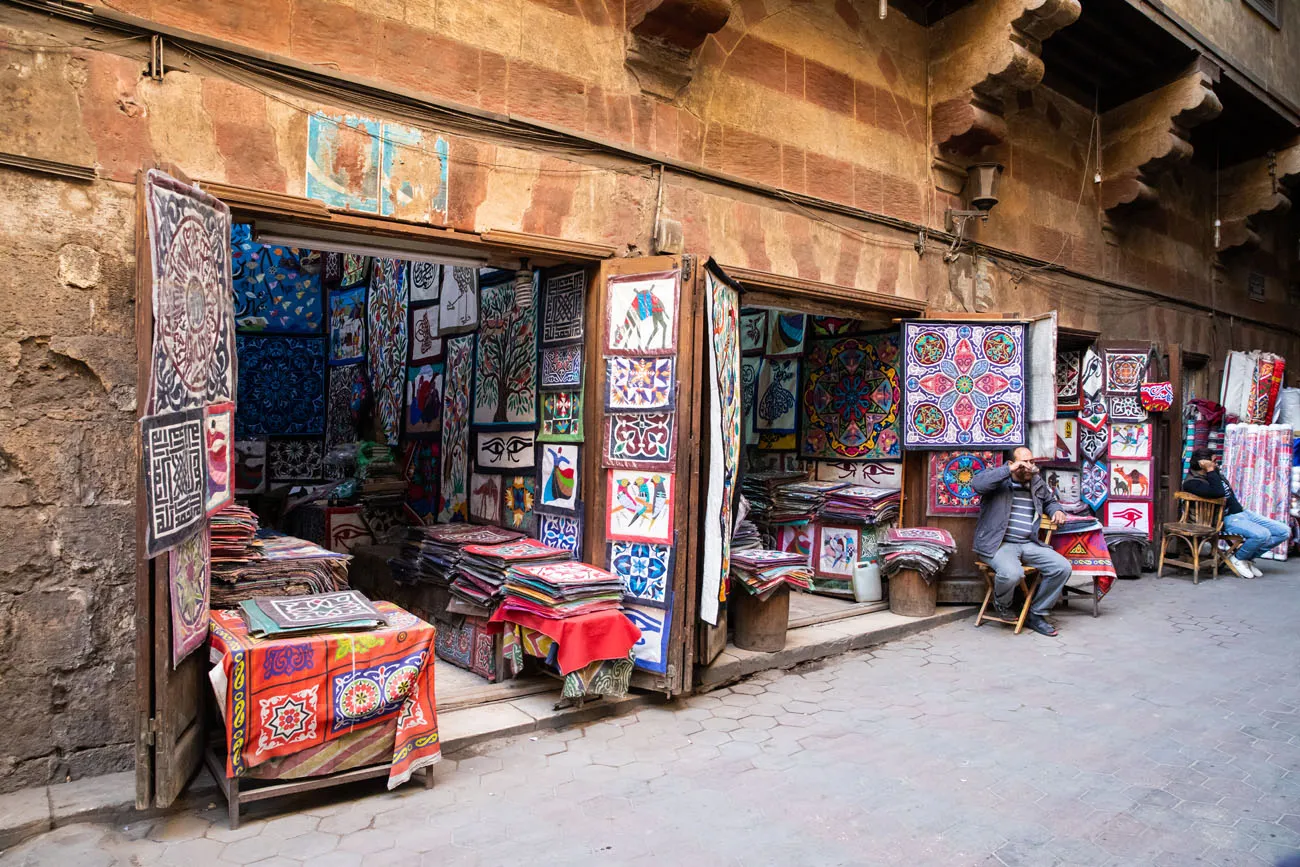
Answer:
[0,564,1300,867]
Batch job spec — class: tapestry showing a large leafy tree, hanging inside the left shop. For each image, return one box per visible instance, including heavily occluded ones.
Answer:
[473,282,537,426]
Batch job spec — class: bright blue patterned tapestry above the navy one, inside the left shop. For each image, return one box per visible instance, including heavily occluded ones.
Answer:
[230,222,325,334]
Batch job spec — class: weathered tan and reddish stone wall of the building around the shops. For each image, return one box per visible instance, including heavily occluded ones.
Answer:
[0,0,1300,790]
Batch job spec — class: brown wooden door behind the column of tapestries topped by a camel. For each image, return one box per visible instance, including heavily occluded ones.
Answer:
[582,256,703,695]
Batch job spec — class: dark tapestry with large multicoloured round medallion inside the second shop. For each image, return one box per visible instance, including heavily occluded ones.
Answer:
[800,334,902,460]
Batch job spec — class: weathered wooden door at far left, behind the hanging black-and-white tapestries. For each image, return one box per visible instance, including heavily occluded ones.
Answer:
[134,170,210,810]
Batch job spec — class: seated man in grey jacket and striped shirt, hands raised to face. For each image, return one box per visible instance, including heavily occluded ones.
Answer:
[971,446,1070,636]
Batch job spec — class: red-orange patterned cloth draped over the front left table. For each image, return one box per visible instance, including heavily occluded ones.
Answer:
[211,602,442,789]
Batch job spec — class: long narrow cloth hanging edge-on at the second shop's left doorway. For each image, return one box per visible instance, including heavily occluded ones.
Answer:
[699,269,743,624]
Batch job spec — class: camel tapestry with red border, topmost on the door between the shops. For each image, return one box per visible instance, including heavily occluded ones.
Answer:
[605,270,680,355]
